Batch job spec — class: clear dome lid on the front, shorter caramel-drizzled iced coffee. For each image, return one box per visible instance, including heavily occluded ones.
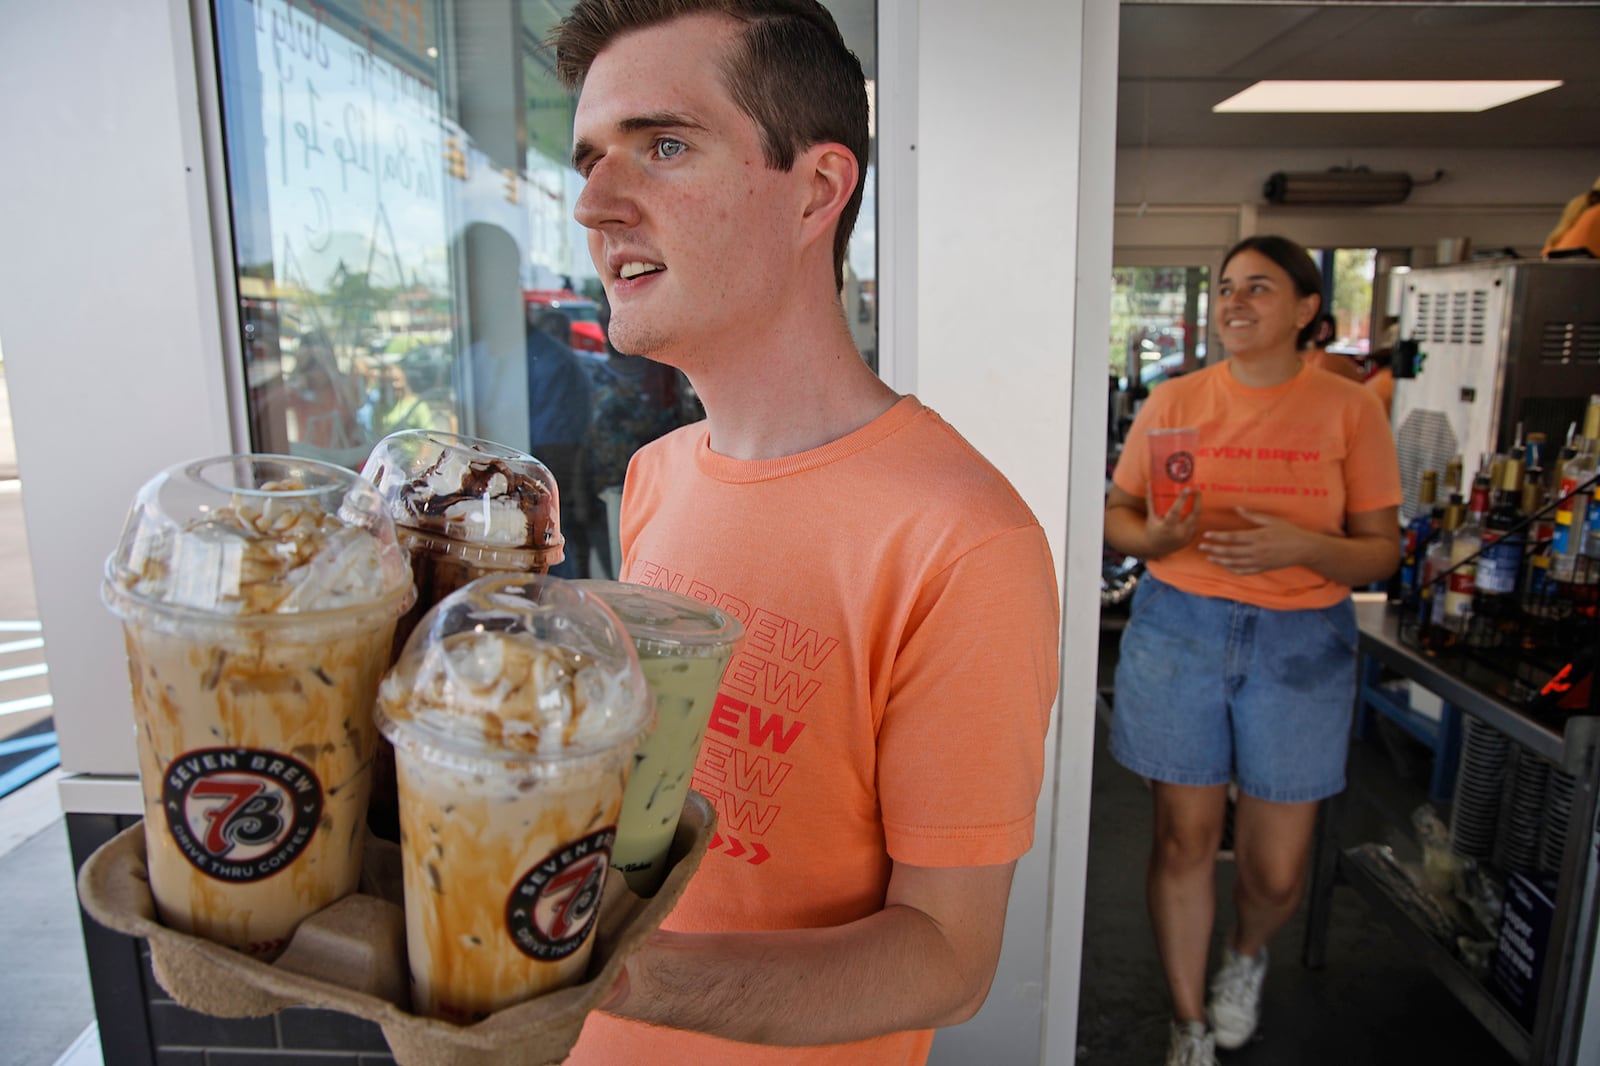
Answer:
[378,573,654,762]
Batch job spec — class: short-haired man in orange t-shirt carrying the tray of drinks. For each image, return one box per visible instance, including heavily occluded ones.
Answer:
[555,0,1058,1066]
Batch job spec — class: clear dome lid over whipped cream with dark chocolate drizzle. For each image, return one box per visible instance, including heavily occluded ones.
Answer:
[362,429,565,565]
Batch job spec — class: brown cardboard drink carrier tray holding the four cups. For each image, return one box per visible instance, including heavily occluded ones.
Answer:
[78,792,717,1066]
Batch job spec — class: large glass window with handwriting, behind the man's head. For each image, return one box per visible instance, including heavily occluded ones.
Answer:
[213,0,877,576]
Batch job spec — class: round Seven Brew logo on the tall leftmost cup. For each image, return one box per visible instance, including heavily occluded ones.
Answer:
[162,747,322,882]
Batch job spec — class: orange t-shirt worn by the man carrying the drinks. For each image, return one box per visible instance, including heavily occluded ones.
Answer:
[570,397,1059,1066]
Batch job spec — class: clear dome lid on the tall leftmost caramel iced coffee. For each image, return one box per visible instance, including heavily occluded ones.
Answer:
[104,455,413,618]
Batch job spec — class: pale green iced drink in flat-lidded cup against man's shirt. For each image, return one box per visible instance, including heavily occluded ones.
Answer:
[573,581,744,896]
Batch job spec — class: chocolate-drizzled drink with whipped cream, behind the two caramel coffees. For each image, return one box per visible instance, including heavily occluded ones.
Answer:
[362,429,565,840]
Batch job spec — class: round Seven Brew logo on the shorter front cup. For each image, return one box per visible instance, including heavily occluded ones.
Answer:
[506,828,616,962]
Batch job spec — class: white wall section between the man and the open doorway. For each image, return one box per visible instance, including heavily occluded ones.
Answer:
[915,0,1117,1066]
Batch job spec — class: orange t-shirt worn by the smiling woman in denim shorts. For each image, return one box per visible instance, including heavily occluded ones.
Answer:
[1112,363,1400,610]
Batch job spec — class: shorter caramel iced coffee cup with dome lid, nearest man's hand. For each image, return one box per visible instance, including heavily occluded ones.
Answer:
[376,575,654,1024]
